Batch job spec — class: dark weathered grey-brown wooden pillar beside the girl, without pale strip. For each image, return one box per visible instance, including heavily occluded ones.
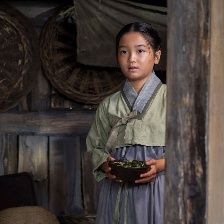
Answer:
[165,0,210,224]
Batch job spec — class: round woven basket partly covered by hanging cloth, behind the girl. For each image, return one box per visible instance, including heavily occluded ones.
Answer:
[40,6,125,104]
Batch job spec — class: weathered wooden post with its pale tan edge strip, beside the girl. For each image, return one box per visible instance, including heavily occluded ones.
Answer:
[165,0,224,224]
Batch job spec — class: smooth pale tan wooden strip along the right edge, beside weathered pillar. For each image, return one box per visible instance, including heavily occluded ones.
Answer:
[207,0,224,223]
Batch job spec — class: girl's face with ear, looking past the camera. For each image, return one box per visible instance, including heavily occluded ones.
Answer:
[118,32,161,86]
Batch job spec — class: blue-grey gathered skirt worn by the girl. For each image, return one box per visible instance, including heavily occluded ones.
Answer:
[96,145,165,224]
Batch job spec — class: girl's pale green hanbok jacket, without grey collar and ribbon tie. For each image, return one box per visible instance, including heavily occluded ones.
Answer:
[86,83,166,181]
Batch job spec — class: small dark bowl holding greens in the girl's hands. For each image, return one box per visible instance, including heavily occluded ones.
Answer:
[109,160,150,181]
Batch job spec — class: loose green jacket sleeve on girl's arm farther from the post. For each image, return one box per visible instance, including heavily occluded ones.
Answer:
[86,103,111,181]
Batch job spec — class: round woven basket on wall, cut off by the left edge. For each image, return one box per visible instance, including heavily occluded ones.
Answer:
[0,3,40,111]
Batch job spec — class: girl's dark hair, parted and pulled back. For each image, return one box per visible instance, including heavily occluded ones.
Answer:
[116,22,162,53]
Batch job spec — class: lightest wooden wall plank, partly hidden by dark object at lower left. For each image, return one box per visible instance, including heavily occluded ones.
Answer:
[18,136,48,208]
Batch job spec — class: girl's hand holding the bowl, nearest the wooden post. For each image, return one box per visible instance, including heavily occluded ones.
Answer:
[135,159,165,183]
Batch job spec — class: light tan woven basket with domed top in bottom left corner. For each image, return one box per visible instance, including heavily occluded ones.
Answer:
[0,206,60,224]
